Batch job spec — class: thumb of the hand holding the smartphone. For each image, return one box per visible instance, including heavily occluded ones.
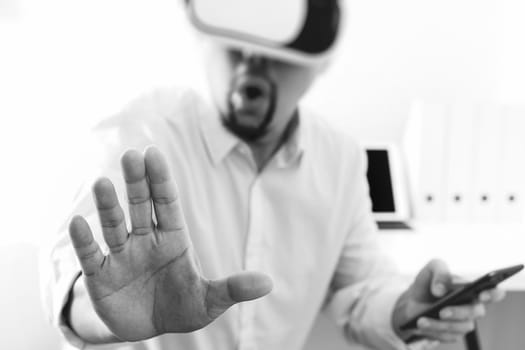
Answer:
[412,260,451,302]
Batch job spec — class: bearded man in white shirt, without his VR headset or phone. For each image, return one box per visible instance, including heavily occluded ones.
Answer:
[42,0,502,349]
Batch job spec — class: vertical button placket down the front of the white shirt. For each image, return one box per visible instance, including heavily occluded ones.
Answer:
[239,176,264,350]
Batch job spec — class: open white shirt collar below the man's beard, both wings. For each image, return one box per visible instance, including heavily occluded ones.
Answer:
[199,102,307,165]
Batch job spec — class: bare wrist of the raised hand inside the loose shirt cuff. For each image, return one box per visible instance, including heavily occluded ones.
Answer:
[64,276,121,344]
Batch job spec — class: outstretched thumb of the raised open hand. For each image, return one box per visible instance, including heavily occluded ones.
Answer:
[206,272,273,319]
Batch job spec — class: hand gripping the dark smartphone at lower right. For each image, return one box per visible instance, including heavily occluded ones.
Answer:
[392,260,505,343]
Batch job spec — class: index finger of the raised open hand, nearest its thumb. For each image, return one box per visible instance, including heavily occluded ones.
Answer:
[144,147,186,232]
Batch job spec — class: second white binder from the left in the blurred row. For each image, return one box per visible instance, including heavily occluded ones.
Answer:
[444,103,475,221]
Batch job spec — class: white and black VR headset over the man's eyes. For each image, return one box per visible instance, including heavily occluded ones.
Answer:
[187,0,342,65]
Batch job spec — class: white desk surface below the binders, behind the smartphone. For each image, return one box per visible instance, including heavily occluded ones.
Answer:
[380,223,525,291]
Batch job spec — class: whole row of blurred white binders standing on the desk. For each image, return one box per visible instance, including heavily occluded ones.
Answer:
[404,102,525,223]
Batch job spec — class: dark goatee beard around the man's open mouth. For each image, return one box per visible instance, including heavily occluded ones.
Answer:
[221,74,277,142]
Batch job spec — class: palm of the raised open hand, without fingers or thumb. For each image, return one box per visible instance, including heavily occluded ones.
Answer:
[86,227,206,340]
